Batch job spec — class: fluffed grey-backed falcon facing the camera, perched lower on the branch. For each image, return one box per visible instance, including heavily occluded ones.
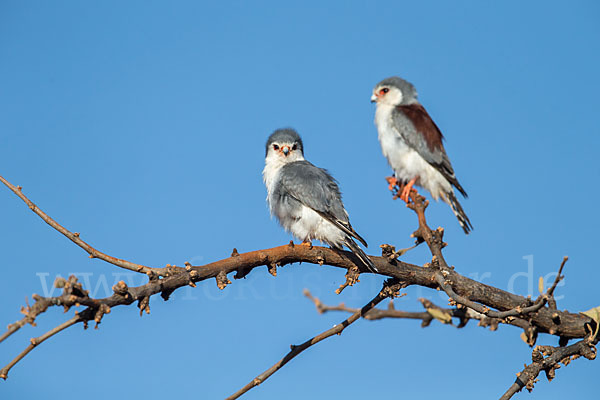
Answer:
[263,129,377,272]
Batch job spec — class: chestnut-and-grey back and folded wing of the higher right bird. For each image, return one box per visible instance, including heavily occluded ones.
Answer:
[392,103,467,197]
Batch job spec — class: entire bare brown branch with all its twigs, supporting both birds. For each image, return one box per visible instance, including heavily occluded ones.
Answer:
[0,177,597,398]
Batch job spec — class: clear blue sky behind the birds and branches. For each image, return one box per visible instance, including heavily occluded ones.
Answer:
[0,1,600,399]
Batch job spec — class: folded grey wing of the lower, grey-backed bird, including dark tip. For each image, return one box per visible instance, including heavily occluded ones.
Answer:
[275,161,367,246]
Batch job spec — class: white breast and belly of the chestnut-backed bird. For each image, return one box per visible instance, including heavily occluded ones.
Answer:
[375,104,452,200]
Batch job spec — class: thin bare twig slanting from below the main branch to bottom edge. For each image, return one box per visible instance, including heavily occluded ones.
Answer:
[226,280,403,400]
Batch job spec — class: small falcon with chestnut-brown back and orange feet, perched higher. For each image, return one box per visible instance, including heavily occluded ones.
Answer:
[371,76,473,234]
